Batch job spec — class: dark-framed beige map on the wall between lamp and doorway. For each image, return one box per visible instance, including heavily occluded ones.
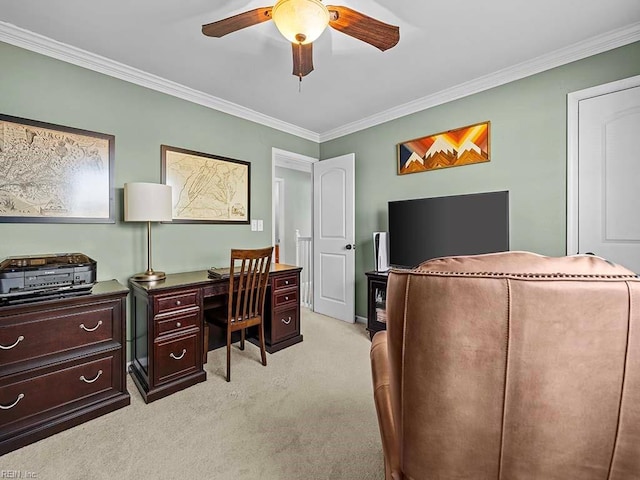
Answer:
[161,145,251,224]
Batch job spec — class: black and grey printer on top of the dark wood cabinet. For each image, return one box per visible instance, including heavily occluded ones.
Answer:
[0,253,96,305]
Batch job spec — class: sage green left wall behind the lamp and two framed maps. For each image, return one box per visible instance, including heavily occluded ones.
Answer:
[0,43,319,352]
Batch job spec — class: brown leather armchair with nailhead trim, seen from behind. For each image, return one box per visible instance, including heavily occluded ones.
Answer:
[371,252,640,480]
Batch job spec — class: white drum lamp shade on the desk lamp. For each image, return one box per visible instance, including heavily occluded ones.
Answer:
[124,182,173,222]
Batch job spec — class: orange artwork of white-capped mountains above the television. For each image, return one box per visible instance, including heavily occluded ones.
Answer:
[398,121,490,175]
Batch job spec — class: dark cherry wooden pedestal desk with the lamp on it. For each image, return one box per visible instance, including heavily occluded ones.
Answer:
[129,264,302,403]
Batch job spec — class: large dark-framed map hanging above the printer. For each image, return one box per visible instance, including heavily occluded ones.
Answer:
[0,114,115,223]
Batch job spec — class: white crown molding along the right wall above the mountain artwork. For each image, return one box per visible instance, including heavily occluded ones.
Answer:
[320,22,640,143]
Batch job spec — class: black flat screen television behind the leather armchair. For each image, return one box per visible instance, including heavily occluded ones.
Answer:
[388,191,509,268]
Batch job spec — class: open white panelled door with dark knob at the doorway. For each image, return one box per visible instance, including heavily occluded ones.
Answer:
[313,153,356,323]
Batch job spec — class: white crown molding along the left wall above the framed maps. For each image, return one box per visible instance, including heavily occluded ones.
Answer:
[0,21,320,143]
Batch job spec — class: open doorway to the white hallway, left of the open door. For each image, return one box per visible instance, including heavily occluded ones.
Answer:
[272,148,318,307]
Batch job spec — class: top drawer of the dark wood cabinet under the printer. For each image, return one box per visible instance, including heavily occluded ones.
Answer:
[0,303,120,366]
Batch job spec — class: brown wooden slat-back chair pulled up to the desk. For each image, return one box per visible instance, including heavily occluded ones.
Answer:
[204,247,273,382]
